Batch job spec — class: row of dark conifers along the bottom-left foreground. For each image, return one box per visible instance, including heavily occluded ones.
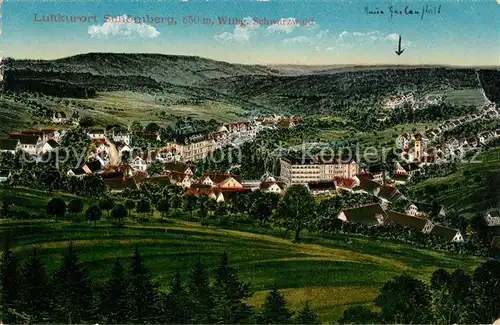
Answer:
[0,243,319,324]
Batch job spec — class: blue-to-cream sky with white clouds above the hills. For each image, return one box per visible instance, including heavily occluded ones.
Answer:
[0,0,500,66]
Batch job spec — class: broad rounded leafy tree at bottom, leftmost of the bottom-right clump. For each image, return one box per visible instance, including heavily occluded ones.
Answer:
[375,275,430,324]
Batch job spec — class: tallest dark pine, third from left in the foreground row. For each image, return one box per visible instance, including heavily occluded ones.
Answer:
[52,243,94,324]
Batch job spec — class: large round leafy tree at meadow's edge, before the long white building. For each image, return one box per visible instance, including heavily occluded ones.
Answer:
[273,184,315,241]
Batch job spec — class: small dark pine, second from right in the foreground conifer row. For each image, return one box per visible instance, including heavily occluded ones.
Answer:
[257,283,292,324]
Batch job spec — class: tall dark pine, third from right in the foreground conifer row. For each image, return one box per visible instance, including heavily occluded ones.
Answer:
[213,252,252,324]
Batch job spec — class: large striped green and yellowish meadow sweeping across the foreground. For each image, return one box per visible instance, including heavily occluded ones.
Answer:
[0,211,481,322]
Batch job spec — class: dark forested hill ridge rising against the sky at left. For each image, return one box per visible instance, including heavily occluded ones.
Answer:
[4,53,279,88]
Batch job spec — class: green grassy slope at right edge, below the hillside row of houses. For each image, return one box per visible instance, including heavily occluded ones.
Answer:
[412,148,500,214]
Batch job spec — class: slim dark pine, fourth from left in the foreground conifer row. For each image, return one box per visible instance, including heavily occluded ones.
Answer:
[99,259,130,324]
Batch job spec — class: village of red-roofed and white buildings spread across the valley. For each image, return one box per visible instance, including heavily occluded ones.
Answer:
[0,99,500,246]
